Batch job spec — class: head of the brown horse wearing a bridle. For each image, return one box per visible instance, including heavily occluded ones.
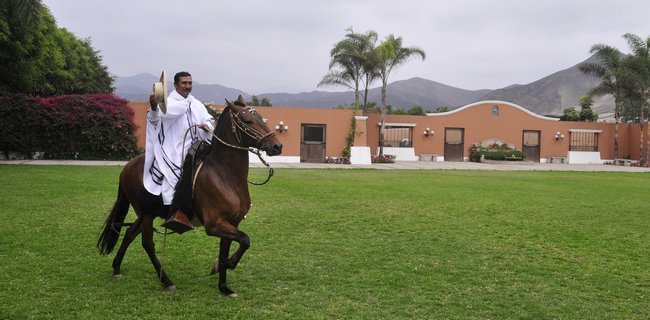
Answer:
[222,95,282,156]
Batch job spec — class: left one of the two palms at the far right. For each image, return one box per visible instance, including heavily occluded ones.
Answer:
[578,44,626,159]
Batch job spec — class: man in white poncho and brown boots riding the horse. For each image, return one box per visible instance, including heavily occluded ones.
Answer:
[140,71,214,233]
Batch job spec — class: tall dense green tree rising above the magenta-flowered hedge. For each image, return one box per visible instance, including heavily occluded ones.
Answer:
[0,0,113,96]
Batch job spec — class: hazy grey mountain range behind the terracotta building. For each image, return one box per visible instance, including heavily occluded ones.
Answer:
[115,56,613,116]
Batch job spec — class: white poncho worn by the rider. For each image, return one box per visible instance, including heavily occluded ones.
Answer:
[144,91,214,205]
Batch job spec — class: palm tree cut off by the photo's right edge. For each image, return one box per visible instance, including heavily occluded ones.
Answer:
[623,33,650,165]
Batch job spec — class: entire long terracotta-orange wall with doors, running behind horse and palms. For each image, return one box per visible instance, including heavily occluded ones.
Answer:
[130,101,640,159]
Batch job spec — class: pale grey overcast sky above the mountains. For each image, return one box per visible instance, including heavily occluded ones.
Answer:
[43,0,650,94]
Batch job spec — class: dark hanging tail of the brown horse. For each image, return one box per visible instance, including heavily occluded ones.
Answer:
[97,183,129,254]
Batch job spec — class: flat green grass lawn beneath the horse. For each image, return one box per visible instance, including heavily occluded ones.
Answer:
[0,165,650,319]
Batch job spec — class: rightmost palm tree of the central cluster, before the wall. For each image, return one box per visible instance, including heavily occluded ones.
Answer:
[371,34,426,156]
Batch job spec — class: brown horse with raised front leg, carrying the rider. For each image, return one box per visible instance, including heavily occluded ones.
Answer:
[97,96,282,297]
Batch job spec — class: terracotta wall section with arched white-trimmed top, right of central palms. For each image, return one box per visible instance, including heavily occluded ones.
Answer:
[367,101,647,159]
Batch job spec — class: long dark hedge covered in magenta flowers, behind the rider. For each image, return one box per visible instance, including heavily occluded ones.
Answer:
[0,94,142,160]
